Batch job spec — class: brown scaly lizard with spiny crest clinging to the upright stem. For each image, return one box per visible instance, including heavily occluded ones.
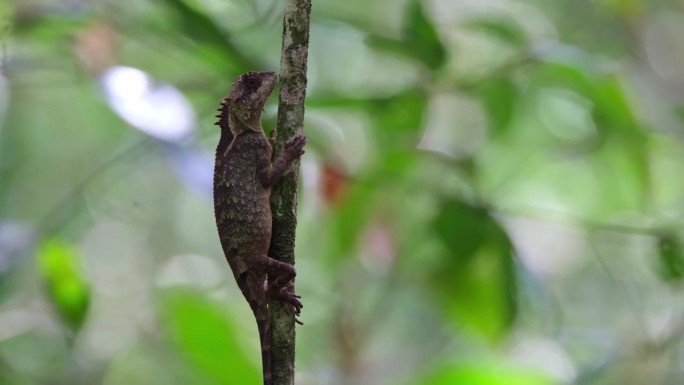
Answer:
[214,71,306,385]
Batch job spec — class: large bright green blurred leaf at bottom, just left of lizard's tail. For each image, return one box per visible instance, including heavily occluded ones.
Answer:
[162,291,261,385]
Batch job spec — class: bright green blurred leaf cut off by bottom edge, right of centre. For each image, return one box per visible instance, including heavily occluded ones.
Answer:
[414,364,554,385]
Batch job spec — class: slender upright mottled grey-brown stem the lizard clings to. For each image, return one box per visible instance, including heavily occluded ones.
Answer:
[269,0,311,385]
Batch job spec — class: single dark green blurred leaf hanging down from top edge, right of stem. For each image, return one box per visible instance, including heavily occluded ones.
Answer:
[403,0,446,70]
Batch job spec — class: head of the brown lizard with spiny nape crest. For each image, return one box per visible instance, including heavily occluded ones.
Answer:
[221,71,276,136]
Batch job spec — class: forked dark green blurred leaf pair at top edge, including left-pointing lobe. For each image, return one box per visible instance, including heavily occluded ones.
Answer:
[366,0,447,70]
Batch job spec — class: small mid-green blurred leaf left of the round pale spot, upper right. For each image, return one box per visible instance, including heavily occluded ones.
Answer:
[477,78,518,135]
